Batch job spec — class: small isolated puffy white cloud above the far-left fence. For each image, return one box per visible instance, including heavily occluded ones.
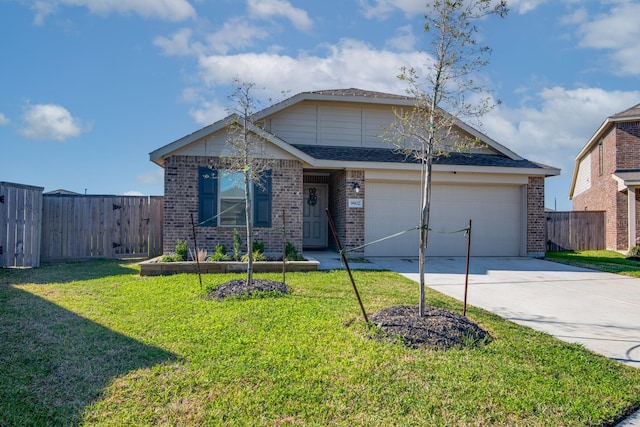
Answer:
[20,104,88,141]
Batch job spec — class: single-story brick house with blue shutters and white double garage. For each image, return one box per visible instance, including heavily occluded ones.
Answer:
[150,89,560,257]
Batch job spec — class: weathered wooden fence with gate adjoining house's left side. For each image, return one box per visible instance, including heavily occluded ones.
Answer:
[41,195,164,261]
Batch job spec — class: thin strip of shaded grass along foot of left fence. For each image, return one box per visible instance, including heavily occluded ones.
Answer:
[0,259,139,285]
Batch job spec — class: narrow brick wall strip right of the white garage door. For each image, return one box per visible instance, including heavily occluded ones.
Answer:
[527,176,546,257]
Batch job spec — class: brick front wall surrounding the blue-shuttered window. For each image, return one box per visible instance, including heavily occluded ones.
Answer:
[163,156,303,254]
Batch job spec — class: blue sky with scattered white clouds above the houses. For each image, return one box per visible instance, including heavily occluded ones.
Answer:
[0,0,640,210]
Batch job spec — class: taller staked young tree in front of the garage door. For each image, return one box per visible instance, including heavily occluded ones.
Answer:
[383,0,508,316]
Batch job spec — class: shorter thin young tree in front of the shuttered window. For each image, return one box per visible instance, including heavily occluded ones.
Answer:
[226,77,270,286]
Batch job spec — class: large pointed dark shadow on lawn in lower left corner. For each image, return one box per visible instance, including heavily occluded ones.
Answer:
[0,283,178,426]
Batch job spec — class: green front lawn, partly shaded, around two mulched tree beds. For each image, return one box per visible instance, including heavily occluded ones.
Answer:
[0,261,640,426]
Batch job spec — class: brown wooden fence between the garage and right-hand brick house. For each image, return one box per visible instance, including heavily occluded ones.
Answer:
[547,211,606,251]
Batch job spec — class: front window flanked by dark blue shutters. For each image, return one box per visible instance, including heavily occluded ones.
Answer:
[198,167,271,227]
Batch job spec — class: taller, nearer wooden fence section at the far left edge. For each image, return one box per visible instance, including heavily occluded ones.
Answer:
[0,182,43,267]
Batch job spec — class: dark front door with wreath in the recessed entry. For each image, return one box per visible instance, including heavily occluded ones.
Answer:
[302,184,328,248]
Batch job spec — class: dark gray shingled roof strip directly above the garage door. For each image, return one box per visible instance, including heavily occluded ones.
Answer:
[293,144,546,169]
